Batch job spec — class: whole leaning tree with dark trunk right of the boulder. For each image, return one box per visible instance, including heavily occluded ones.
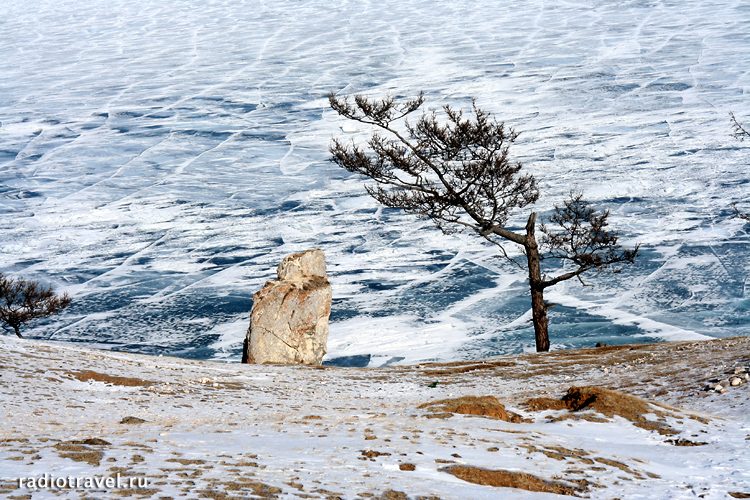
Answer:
[328,93,638,351]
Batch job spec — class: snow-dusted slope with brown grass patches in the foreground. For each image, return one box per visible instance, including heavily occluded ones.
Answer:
[0,337,750,500]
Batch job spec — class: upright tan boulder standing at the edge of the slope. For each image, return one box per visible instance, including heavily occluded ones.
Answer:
[242,249,331,365]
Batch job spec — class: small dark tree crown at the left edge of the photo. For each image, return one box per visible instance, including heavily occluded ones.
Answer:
[0,273,71,338]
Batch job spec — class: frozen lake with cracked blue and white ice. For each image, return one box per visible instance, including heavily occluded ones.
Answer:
[0,0,750,365]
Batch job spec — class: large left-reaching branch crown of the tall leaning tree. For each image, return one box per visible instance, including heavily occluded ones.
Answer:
[328,93,539,231]
